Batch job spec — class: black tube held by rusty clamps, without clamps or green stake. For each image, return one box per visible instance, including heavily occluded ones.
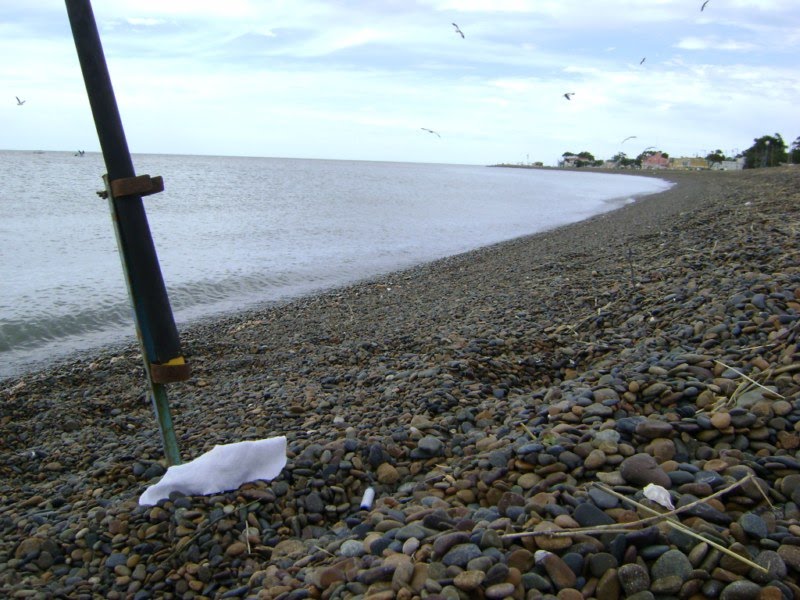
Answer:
[66,0,181,364]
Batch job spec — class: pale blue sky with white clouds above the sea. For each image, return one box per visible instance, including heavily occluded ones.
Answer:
[0,0,800,165]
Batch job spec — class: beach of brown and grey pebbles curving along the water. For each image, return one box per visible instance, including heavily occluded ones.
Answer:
[0,167,800,600]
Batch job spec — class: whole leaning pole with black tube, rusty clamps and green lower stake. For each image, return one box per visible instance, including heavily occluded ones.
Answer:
[65,0,188,464]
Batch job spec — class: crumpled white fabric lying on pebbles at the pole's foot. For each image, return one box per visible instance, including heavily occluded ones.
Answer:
[139,436,286,505]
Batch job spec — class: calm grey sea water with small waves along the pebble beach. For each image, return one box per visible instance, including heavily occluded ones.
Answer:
[0,151,669,378]
